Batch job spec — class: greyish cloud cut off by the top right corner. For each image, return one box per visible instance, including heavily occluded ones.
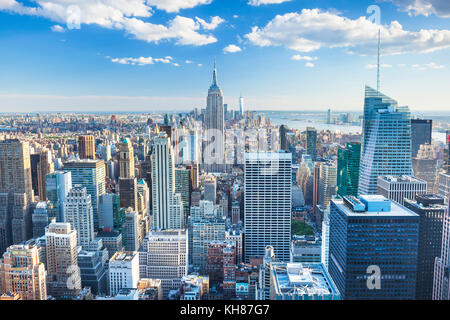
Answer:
[384,0,450,18]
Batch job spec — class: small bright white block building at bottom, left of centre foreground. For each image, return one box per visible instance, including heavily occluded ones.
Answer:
[108,251,140,296]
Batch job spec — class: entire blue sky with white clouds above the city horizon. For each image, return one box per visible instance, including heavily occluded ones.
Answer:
[0,0,450,112]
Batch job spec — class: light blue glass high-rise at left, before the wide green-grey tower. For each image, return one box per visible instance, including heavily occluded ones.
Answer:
[45,171,72,222]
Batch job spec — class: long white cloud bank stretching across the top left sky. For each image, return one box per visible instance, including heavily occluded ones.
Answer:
[0,0,221,46]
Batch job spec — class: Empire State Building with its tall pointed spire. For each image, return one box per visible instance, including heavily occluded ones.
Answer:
[203,60,225,172]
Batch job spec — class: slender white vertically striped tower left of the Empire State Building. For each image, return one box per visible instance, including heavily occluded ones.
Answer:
[151,134,184,230]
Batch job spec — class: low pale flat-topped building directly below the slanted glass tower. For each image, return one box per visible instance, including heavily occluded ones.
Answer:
[378,176,427,205]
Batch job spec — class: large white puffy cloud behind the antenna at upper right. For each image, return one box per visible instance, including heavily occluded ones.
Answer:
[245,9,450,55]
